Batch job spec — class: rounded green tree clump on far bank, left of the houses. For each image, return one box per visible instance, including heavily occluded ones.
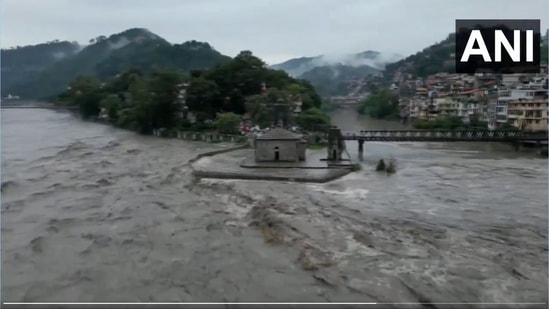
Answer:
[358,88,399,119]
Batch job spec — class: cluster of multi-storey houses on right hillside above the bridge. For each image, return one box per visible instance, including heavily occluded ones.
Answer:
[391,66,548,132]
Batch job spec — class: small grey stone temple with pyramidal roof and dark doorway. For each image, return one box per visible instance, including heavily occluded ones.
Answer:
[255,127,307,162]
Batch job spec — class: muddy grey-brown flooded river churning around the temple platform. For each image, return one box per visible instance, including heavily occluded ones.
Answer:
[1,109,548,308]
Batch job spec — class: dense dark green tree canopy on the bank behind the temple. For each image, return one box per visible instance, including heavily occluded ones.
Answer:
[55,51,329,134]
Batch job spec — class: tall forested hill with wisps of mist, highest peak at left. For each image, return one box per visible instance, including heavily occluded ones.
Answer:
[6,28,230,99]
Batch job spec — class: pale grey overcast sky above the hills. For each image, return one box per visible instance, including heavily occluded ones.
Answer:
[0,0,549,64]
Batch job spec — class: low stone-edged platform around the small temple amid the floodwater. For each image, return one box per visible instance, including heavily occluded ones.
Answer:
[191,149,351,183]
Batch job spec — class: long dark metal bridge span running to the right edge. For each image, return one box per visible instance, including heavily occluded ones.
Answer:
[343,130,548,142]
